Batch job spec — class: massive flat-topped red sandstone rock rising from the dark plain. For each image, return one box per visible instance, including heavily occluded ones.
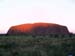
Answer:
[7,22,69,35]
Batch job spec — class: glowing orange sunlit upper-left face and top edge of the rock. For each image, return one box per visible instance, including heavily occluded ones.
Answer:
[9,23,61,32]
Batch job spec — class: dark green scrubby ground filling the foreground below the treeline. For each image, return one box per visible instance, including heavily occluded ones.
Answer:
[0,35,75,56]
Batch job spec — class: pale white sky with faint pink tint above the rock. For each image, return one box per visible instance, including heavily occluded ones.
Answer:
[0,0,75,33]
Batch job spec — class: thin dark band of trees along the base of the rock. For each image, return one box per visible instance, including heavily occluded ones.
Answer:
[0,33,75,37]
